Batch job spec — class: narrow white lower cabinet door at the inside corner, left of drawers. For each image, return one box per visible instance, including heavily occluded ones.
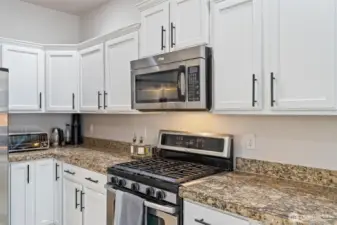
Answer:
[52,160,63,225]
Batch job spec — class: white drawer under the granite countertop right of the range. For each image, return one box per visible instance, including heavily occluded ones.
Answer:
[184,201,250,225]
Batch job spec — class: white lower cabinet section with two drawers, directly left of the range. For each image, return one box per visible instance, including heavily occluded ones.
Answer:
[63,164,107,225]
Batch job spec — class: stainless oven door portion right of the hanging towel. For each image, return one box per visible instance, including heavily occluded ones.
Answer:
[144,201,178,225]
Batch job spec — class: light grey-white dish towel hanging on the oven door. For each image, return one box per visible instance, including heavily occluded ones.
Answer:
[114,190,144,225]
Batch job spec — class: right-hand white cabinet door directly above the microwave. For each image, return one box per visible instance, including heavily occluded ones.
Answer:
[170,0,209,51]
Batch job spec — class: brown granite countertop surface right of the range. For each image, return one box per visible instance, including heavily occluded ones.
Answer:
[179,172,337,225]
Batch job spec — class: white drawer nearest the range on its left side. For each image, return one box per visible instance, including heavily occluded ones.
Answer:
[81,169,107,194]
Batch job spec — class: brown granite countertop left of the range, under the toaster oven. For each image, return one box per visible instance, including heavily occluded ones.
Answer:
[9,147,132,174]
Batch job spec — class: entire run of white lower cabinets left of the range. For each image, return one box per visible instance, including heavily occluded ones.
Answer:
[10,159,107,225]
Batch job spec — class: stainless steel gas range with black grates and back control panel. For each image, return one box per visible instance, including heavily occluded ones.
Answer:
[106,131,233,225]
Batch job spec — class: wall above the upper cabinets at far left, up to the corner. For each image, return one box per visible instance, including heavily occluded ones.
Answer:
[0,0,80,44]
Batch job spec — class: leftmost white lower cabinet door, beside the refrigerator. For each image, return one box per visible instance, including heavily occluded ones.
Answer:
[10,163,35,225]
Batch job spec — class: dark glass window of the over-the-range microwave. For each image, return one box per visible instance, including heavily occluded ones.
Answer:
[135,70,185,103]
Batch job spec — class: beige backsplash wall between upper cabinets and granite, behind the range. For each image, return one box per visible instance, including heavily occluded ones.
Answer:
[84,113,337,170]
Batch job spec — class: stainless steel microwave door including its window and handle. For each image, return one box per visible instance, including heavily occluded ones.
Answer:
[132,63,187,110]
